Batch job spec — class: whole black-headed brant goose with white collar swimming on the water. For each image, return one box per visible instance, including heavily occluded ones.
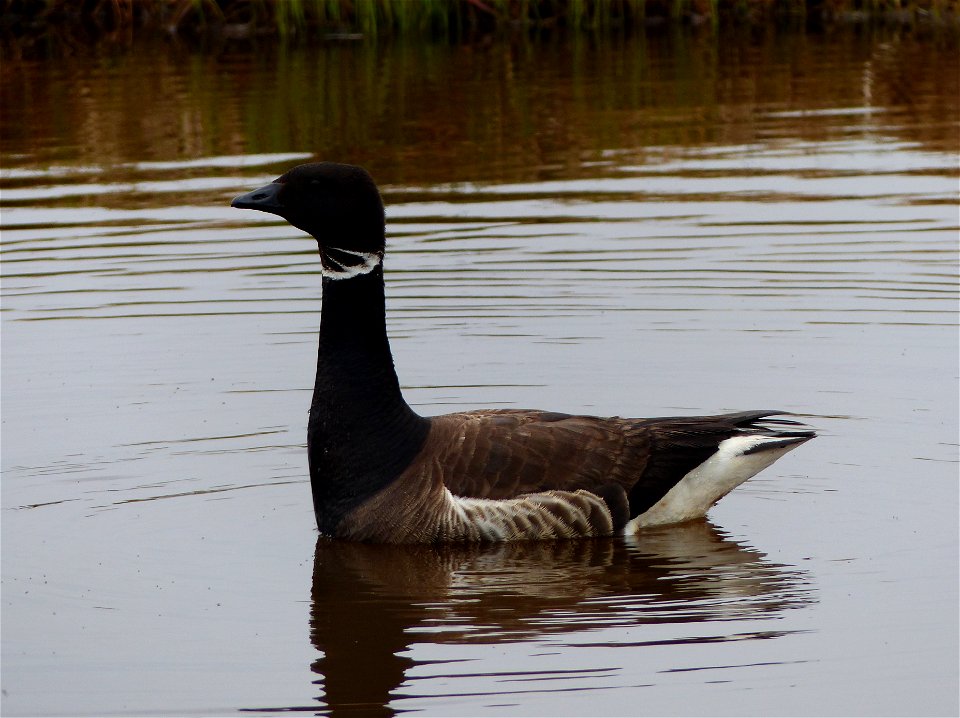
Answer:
[232,162,814,543]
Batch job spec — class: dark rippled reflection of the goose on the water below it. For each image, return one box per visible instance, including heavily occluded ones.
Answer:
[310,521,814,716]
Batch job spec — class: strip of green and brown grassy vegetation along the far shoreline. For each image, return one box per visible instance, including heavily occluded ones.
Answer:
[0,0,960,45]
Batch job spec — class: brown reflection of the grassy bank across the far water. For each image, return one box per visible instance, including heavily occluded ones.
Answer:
[0,30,960,184]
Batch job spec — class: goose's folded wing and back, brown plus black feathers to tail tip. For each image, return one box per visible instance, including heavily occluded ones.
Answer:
[429,409,813,525]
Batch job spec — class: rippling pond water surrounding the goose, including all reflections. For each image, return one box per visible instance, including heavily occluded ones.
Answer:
[0,29,960,715]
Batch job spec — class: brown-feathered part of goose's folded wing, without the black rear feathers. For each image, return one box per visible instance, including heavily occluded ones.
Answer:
[430,410,649,510]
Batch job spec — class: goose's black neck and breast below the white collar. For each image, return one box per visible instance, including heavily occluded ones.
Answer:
[307,265,429,534]
